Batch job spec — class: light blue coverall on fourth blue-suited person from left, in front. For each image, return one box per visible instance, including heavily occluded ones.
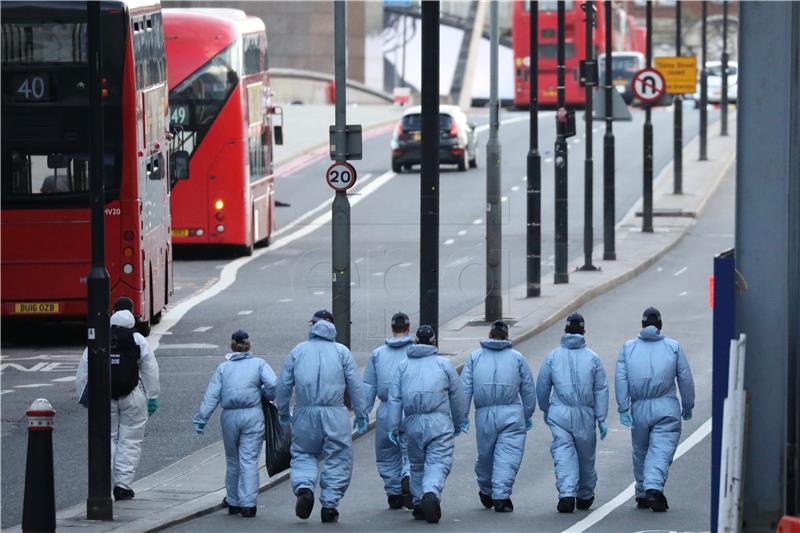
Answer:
[389,344,465,506]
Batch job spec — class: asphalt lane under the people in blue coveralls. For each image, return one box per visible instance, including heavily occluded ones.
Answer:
[174,156,734,533]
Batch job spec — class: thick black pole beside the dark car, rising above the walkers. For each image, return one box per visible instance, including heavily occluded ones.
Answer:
[419,1,439,333]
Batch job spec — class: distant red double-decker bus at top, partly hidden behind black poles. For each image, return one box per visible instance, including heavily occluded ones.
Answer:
[511,0,635,108]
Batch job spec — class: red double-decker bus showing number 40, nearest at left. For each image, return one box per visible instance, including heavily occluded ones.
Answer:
[0,0,172,333]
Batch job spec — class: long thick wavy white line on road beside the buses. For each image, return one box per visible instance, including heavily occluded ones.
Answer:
[150,171,395,352]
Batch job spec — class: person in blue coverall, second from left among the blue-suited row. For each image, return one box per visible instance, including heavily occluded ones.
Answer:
[277,310,368,522]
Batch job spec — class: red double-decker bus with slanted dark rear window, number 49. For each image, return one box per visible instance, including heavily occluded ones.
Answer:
[164,9,277,255]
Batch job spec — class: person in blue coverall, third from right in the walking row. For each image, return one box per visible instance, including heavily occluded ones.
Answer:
[461,320,536,513]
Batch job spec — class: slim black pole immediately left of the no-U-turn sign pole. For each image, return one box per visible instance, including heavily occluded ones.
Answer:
[603,0,617,261]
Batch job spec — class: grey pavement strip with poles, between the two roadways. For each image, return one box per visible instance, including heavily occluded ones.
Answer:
[1,106,735,531]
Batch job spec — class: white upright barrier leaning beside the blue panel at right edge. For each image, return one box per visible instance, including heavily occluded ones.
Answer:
[718,334,752,532]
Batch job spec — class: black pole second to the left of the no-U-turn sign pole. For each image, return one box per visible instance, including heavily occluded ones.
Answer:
[580,1,598,271]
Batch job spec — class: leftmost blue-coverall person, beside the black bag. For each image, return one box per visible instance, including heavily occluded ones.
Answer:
[192,330,278,517]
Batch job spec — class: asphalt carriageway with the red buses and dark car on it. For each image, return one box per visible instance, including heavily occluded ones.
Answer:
[0,108,716,527]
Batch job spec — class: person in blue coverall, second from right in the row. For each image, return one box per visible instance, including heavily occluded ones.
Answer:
[536,313,608,513]
